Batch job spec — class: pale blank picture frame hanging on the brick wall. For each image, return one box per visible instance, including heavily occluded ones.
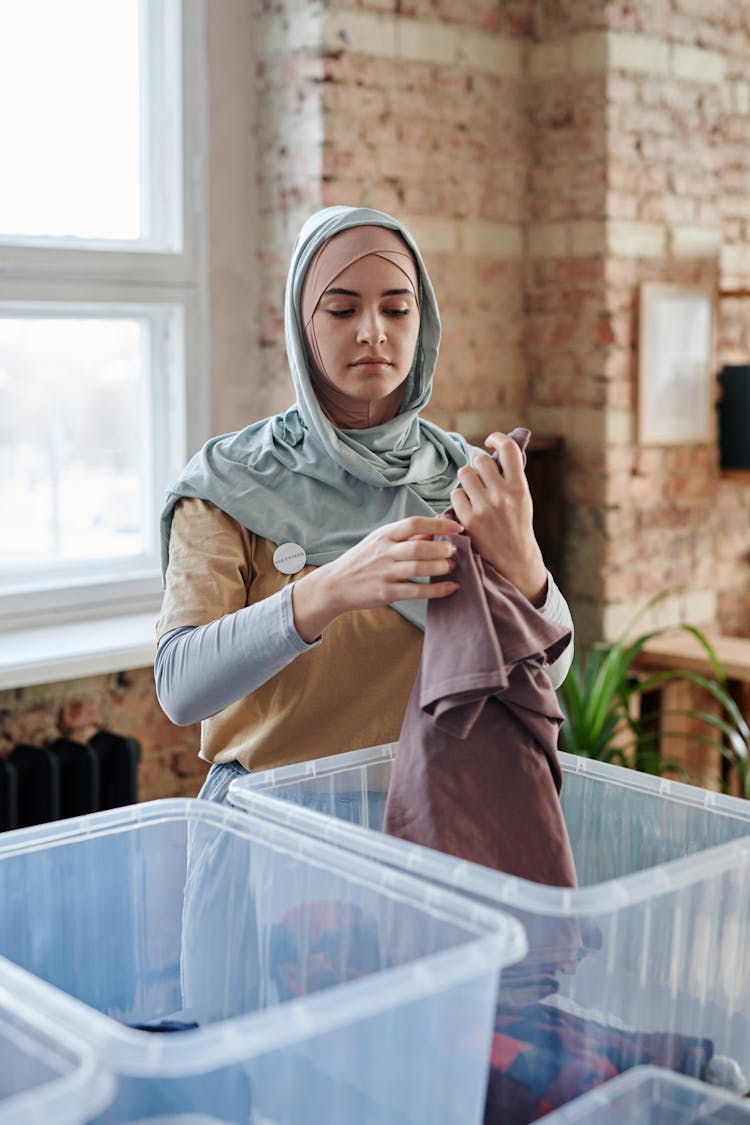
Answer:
[638,281,716,446]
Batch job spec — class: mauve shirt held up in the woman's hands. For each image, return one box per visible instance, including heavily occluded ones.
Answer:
[385,430,576,887]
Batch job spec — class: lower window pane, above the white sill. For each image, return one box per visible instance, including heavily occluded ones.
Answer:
[0,317,153,579]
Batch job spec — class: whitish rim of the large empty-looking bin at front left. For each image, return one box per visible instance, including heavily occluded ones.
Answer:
[0,798,528,1076]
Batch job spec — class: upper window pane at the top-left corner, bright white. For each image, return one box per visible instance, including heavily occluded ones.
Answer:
[0,0,179,244]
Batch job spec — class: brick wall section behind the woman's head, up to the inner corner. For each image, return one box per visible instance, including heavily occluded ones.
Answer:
[259,0,528,433]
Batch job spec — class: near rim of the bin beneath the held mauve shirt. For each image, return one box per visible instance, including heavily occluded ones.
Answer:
[229,779,750,917]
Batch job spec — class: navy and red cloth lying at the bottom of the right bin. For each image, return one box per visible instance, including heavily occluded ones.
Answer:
[484,1004,713,1125]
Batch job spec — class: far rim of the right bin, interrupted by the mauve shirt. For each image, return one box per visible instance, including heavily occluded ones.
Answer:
[237,743,750,820]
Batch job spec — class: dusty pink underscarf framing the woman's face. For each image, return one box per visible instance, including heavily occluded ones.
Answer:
[300,226,419,430]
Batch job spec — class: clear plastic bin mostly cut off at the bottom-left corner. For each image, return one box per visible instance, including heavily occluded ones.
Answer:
[0,963,115,1125]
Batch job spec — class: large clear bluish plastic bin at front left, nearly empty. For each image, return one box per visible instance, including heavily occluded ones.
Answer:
[0,800,526,1125]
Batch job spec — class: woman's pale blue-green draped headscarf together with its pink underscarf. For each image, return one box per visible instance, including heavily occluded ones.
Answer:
[161,207,470,628]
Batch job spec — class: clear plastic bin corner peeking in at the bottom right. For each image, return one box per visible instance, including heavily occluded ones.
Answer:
[544,1067,750,1125]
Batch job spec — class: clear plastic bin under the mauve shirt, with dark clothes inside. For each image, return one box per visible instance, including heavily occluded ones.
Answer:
[229,745,750,1123]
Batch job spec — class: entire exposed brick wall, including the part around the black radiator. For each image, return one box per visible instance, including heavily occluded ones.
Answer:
[5,0,750,798]
